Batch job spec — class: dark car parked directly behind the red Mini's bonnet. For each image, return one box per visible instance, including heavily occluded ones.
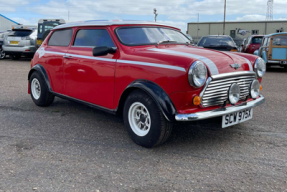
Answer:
[197,35,238,52]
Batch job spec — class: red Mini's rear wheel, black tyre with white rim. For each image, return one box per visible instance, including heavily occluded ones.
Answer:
[29,72,55,107]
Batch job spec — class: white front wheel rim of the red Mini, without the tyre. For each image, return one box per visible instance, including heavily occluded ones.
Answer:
[128,102,151,137]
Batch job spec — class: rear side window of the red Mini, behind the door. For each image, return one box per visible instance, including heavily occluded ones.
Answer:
[48,29,73,47]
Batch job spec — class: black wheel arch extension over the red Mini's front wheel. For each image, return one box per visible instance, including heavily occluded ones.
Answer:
[117,80,177,122]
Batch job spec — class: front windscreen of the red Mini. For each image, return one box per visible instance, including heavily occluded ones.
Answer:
[116,27,190,45]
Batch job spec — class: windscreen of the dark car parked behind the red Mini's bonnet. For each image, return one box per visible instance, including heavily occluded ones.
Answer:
[198,36,236,47]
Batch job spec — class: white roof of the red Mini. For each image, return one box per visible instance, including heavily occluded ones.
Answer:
[54,20,180,30]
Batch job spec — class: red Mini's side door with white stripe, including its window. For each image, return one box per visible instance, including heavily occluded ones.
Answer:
[64,27,118,109]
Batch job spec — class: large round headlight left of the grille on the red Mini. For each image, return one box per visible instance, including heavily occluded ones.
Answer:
[188,61,207,87]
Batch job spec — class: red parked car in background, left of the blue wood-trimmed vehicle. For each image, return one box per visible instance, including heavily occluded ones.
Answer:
[241,35,264,54]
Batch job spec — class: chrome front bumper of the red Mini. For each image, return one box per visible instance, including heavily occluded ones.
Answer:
[175,95,265,121]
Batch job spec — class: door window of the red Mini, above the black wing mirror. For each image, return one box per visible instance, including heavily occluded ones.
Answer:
[74,29,115,47]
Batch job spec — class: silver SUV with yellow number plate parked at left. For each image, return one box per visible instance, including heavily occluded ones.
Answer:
[3,26,37,60]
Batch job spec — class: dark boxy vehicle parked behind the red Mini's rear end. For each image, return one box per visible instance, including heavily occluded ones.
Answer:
[37,19,66,47]
